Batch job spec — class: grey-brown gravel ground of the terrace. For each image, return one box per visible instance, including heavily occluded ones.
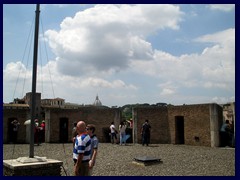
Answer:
[3,143,235,176]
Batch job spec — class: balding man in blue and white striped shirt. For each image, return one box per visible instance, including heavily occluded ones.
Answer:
[73,121,91,176]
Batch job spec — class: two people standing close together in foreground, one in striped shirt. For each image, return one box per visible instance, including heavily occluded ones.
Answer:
[72,121,98,176]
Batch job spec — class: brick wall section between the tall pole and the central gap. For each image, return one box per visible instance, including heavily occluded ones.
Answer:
[45,107,121,142]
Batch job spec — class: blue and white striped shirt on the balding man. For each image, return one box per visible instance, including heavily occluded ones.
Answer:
[73,133,91,162]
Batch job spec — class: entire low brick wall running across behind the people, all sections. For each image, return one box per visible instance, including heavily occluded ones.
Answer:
[3,104,223,147]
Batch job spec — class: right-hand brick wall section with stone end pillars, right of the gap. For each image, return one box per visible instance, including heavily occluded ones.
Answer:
[133,104,222,147]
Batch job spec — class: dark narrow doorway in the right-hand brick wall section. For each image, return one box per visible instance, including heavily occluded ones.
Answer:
[175,116,184,144]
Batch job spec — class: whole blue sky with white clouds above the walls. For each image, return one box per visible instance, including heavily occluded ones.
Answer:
[3,4,235,106]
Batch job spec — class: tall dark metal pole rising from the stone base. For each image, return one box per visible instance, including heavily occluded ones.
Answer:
[29,4,40,158]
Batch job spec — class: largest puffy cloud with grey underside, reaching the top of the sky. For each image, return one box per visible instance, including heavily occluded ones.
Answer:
[46,4,183,76]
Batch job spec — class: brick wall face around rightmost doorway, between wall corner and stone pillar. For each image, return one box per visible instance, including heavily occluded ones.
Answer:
[169,104,211,146]
